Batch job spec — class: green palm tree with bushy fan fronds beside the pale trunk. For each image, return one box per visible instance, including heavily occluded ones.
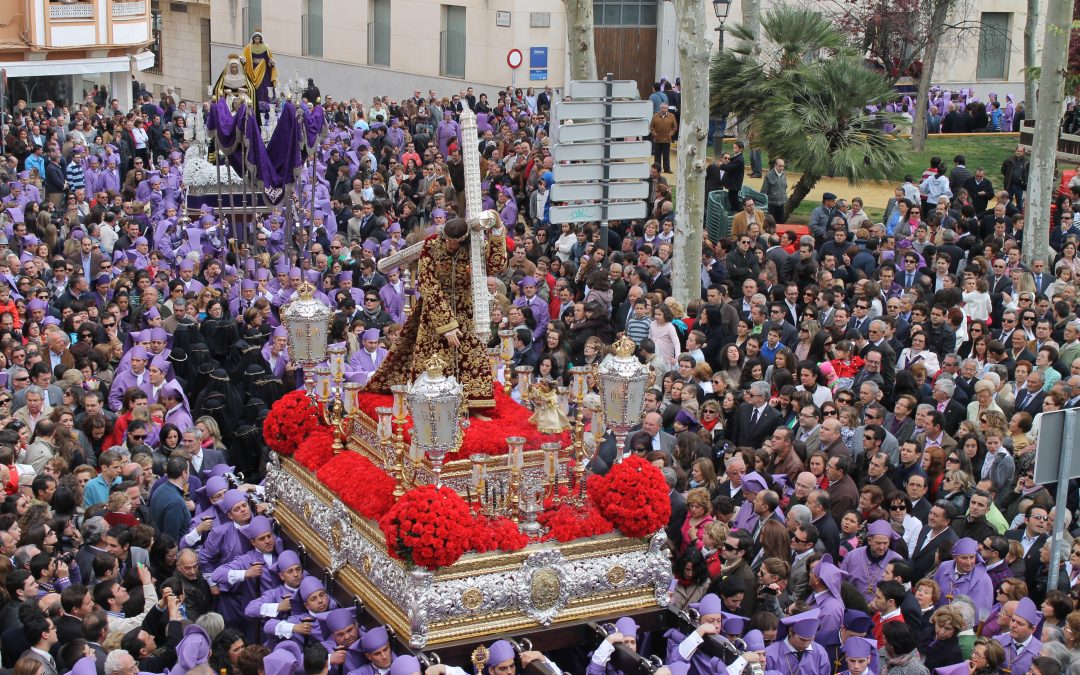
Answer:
[710,5,904,215]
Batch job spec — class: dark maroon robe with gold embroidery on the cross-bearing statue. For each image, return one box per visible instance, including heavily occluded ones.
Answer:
[365,228,507,409]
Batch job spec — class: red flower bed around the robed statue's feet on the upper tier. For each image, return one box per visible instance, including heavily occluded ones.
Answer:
[359,384,570,461]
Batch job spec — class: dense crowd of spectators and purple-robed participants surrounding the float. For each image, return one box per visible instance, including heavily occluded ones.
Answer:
[0,69,1080,675]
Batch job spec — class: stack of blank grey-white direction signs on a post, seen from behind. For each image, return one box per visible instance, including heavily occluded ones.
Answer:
[551,73,652,248]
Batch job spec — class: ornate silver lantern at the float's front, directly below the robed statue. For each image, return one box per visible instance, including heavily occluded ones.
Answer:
[407,355,464,487]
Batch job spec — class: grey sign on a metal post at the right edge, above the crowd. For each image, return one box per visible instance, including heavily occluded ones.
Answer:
[1034,408,1080,589]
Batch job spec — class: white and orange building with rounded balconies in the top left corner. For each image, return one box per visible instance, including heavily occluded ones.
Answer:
[0,0,154,109]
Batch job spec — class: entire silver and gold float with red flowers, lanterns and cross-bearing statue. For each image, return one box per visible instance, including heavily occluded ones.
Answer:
[264,106,672,665]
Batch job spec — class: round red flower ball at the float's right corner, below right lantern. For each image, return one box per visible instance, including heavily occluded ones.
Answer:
[589,456,672,537]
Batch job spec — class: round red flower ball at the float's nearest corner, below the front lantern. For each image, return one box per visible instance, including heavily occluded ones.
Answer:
[379,485,474,569]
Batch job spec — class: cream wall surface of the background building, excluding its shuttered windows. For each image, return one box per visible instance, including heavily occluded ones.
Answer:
[211,0,567,102]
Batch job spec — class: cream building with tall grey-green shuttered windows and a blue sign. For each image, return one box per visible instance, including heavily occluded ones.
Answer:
[211,0,567,103]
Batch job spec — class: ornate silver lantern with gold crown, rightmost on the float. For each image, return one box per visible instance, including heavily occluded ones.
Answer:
[596,336,651,462]
